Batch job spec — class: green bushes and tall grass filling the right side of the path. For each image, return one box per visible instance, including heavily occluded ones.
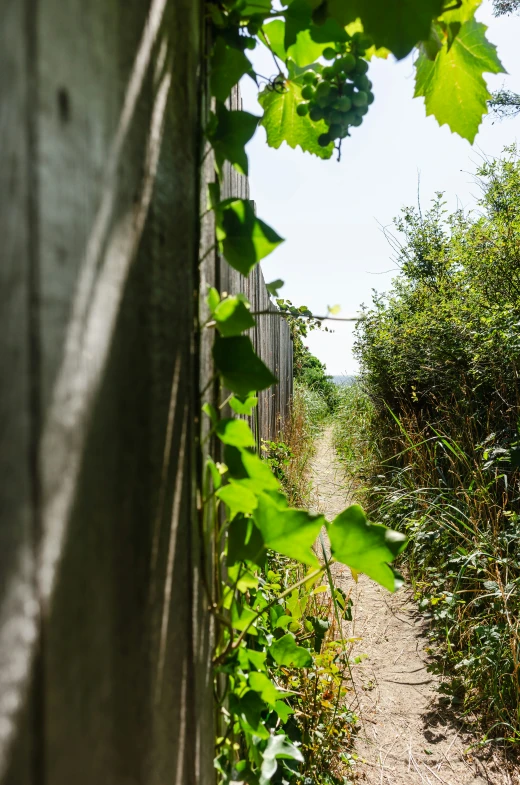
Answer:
[344,147,520,742]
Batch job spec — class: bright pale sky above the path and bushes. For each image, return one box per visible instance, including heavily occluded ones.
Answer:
[241,0,520,375]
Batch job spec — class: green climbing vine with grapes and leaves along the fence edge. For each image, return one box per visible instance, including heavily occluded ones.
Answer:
[203,0,503,785]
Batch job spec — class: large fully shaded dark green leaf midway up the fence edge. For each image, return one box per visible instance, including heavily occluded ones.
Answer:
[213,335,277,398]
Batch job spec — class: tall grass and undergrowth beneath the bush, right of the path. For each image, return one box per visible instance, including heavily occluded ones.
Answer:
[335,384,520,743]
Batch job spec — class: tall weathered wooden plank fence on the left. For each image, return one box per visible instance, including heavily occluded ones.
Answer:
[0,6,292,785]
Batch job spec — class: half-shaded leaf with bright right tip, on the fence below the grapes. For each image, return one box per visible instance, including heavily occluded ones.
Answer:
[216,199,283,276]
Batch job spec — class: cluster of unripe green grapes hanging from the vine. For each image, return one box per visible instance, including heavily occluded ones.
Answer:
[296,41,374,147]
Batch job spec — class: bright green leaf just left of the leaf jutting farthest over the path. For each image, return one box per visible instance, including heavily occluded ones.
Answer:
[254,493,325,567]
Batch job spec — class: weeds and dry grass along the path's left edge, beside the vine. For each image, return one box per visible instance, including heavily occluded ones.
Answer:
[263,383,358,785]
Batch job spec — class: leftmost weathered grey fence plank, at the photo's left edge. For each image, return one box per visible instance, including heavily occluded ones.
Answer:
[0,0,39,785]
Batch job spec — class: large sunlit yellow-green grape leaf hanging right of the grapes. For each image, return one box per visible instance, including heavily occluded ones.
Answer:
[415,21,504,143]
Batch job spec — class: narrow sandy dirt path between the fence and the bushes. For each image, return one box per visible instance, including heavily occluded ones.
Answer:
[312,431,513,785]
